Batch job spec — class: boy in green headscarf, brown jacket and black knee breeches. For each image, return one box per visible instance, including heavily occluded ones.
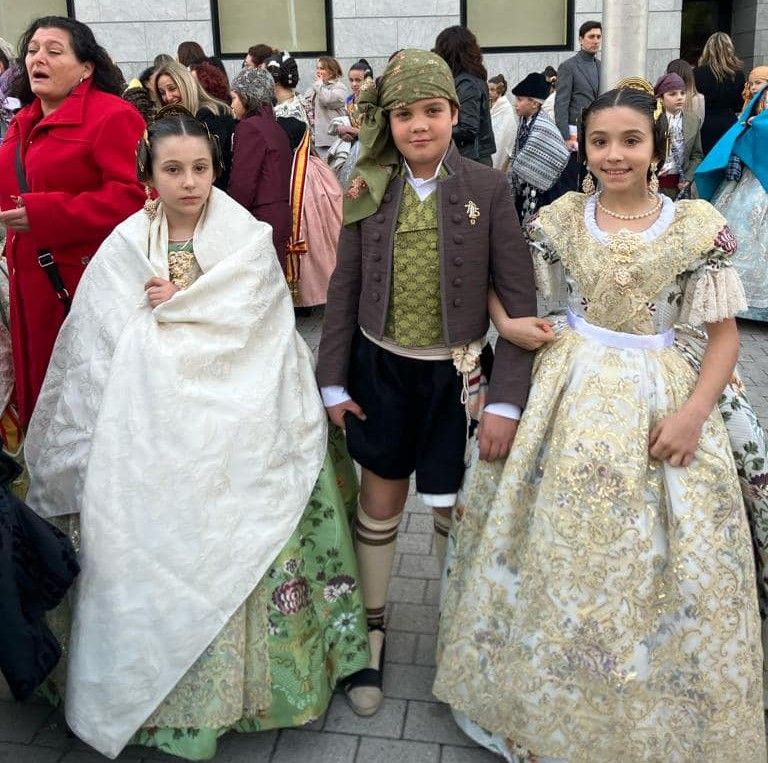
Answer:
[318,50,536,715]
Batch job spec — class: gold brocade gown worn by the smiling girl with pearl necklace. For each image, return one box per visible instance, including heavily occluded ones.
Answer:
[435,193,766,763]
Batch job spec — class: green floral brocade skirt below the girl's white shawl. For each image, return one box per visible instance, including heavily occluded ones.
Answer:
[43,428,368,760]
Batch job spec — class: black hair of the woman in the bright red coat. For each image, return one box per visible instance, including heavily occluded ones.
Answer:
[17,16,125,104]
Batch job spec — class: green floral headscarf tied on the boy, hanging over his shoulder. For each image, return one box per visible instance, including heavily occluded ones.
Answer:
[344,49,459,225]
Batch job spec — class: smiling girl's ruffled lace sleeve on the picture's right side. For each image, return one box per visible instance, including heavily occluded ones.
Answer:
[680,226,747,326]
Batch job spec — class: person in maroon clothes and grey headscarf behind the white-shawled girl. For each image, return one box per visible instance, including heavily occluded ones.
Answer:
[227,69,293,271]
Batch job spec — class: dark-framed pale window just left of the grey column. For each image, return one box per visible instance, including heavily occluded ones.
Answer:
[461,0,574,53]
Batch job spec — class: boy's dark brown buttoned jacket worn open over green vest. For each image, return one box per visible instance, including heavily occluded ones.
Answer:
[317,145,536,414]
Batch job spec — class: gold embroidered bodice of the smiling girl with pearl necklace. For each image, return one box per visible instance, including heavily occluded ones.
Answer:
[529,193,740,334]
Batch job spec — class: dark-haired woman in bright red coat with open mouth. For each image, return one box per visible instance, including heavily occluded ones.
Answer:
[0,16,144,426]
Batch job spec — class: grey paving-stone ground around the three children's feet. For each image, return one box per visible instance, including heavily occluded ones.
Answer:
[0,310,768,763]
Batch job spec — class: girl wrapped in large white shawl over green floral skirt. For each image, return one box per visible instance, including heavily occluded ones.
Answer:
[26,107,368,760]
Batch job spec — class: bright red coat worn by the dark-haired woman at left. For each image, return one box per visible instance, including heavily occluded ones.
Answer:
[0,79,145,426]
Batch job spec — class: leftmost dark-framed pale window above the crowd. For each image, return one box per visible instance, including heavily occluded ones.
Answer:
[211,0,332,58]
